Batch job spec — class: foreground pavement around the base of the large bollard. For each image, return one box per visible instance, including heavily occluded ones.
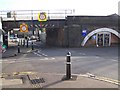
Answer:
[1,72,118,88]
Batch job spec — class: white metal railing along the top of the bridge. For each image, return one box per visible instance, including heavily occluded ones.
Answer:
[0,9,74,21]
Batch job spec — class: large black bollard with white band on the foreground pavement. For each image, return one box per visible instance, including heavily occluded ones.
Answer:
[66,52,71,80]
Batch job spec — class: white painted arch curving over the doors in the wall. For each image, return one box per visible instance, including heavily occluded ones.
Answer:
[81,28,120,46]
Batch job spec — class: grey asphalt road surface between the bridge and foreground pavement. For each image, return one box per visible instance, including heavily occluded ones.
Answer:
[2,47,118,80]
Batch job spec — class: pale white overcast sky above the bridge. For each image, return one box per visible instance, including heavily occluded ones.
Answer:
[0,0,120,16]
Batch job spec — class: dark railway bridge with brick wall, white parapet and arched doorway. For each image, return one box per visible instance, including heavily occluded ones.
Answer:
[1,10,120,47]
